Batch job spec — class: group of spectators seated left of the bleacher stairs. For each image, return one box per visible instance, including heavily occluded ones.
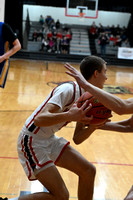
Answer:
[32,15,72,54]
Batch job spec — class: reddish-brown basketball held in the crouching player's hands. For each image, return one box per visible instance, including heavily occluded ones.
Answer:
[77,92,112,125]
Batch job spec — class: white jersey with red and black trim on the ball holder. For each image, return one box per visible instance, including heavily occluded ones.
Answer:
[22,81,84,138]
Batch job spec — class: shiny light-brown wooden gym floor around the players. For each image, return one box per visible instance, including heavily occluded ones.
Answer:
[0,59,133,200]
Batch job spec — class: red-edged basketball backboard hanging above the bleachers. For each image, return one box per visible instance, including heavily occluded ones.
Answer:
[65,0,98,19]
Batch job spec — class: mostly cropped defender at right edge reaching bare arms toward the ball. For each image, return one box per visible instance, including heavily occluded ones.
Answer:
[65,63,133,200]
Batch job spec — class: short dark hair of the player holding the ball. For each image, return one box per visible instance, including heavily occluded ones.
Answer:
[80,56,106,80]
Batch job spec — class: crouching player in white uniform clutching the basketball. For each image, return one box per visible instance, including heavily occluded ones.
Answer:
[0,56,107,200]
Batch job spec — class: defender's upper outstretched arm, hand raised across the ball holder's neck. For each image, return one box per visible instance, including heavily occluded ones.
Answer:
[65,63,133,115]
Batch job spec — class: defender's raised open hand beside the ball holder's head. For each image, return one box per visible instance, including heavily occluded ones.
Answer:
[64,63,87,88]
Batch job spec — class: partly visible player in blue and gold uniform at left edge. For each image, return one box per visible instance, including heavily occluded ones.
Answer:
[0,22,21,88]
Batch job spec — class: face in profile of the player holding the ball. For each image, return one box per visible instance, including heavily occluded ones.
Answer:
[97,64,107,88]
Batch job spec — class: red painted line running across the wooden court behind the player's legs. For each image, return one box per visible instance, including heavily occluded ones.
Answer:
[0,156,133,167]
